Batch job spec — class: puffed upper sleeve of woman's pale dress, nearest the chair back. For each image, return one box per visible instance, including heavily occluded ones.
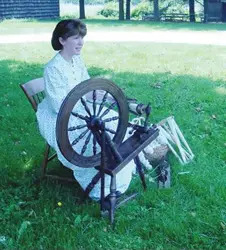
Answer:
[44,66,67,113]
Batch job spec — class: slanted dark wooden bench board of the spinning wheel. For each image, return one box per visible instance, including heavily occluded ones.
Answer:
[100,127,159,176]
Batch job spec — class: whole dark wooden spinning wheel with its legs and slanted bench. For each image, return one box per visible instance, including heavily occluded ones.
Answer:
[56,79,161,223]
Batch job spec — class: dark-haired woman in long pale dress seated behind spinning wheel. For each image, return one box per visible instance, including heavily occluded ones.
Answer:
[36,19,150,200]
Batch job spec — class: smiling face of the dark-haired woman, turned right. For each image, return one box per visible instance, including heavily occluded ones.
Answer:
[60,34,84,56]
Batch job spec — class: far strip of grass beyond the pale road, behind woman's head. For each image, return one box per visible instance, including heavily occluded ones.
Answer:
[0,16,226,35]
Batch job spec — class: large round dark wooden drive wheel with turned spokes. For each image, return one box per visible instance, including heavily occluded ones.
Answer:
[56,79,128,168]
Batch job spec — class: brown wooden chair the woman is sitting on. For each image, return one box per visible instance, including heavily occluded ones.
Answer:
[20,78,74,181]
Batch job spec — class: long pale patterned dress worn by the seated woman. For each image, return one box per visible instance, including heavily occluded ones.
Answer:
[36,53,138,200]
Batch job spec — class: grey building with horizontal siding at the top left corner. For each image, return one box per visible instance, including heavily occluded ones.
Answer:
[0,0,60,19]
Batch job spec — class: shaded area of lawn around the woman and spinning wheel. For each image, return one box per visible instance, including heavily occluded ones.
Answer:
[0,60,226,249]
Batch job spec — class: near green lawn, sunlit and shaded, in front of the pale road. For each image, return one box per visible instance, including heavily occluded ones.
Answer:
[0,21,226,249]
